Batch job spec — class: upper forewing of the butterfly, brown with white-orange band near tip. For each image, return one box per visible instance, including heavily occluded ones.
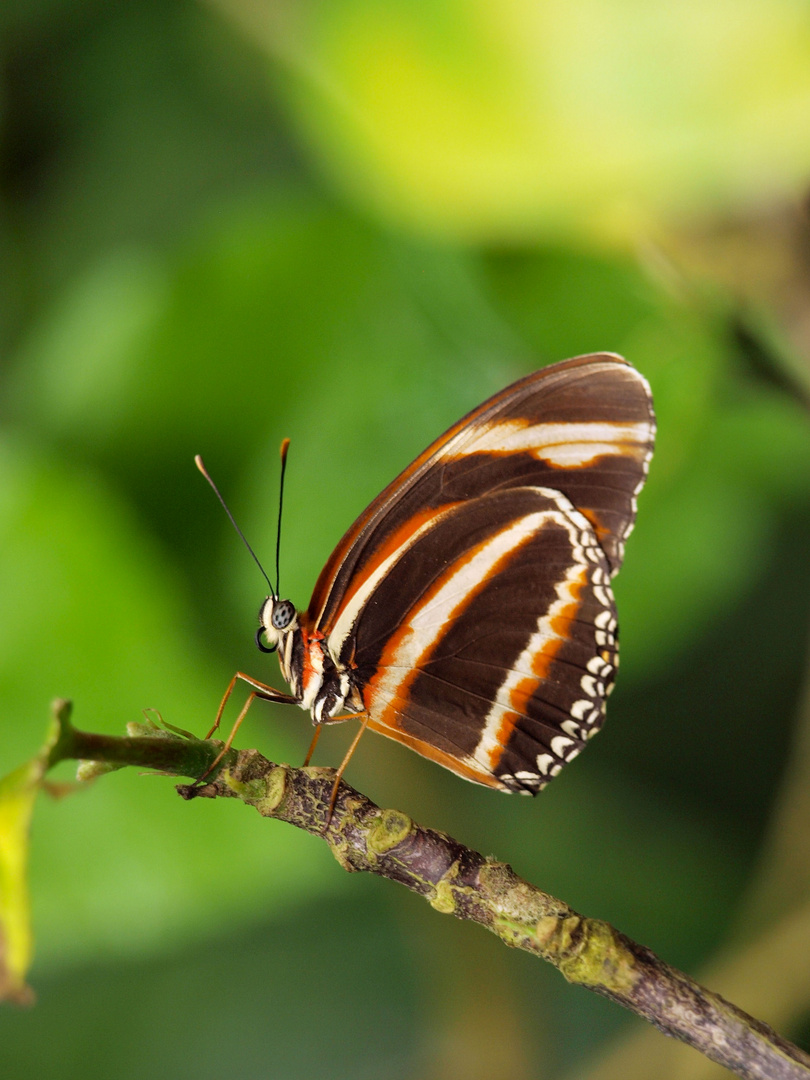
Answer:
[308,353,654,635]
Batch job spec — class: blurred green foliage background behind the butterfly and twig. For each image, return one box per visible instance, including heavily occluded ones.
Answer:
[0,0,810,1080]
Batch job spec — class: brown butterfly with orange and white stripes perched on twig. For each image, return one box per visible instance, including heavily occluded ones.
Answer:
[203,353,656,802]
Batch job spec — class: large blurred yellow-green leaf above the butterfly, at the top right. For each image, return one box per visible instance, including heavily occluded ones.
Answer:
[218,0,810,242]
